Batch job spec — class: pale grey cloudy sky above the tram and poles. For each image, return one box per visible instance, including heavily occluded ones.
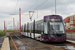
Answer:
[0,0,75,29]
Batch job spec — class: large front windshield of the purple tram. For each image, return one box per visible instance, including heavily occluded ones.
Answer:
[49,19,65,34]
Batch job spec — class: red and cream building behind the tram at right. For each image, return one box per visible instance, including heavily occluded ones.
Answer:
[64,14,75,32]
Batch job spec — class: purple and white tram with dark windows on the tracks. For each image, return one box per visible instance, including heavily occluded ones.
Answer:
[21,15,66,42]
